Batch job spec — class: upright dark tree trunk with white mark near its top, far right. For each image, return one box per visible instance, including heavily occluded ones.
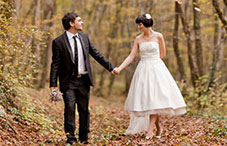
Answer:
[192,0,204,76]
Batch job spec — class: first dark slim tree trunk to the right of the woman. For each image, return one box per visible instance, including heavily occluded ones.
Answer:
[173,2,186,82]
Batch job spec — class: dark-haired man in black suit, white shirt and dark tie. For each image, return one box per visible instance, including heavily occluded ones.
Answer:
[50,12,114,145]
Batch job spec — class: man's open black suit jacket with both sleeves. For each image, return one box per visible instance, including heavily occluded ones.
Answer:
[50,32,114,92]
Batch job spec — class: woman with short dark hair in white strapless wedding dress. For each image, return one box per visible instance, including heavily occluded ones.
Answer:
[112,14,186,139]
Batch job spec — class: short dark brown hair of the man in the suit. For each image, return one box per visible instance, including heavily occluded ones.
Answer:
[62,12,79,30]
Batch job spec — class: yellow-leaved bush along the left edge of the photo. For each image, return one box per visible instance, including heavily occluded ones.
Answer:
[0,5,42,127]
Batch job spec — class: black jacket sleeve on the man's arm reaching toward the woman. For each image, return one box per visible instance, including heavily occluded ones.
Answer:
[87,37,114,72]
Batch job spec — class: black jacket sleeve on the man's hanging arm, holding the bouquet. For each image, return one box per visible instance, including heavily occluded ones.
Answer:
[50,40,61,87]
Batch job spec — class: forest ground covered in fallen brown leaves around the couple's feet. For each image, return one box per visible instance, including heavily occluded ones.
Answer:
[0,88,227,146]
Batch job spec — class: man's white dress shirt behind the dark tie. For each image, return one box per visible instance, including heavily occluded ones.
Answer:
[66,31,87,74]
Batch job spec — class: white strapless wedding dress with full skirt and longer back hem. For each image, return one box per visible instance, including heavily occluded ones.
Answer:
[124,41,186,134]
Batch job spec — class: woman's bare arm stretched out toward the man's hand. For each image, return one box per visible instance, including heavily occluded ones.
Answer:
[118,39,138,73]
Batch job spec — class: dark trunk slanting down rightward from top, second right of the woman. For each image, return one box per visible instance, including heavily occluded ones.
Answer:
[176,1,198,87]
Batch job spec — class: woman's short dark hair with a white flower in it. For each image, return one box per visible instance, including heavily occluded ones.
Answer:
[136,14,153,27]
